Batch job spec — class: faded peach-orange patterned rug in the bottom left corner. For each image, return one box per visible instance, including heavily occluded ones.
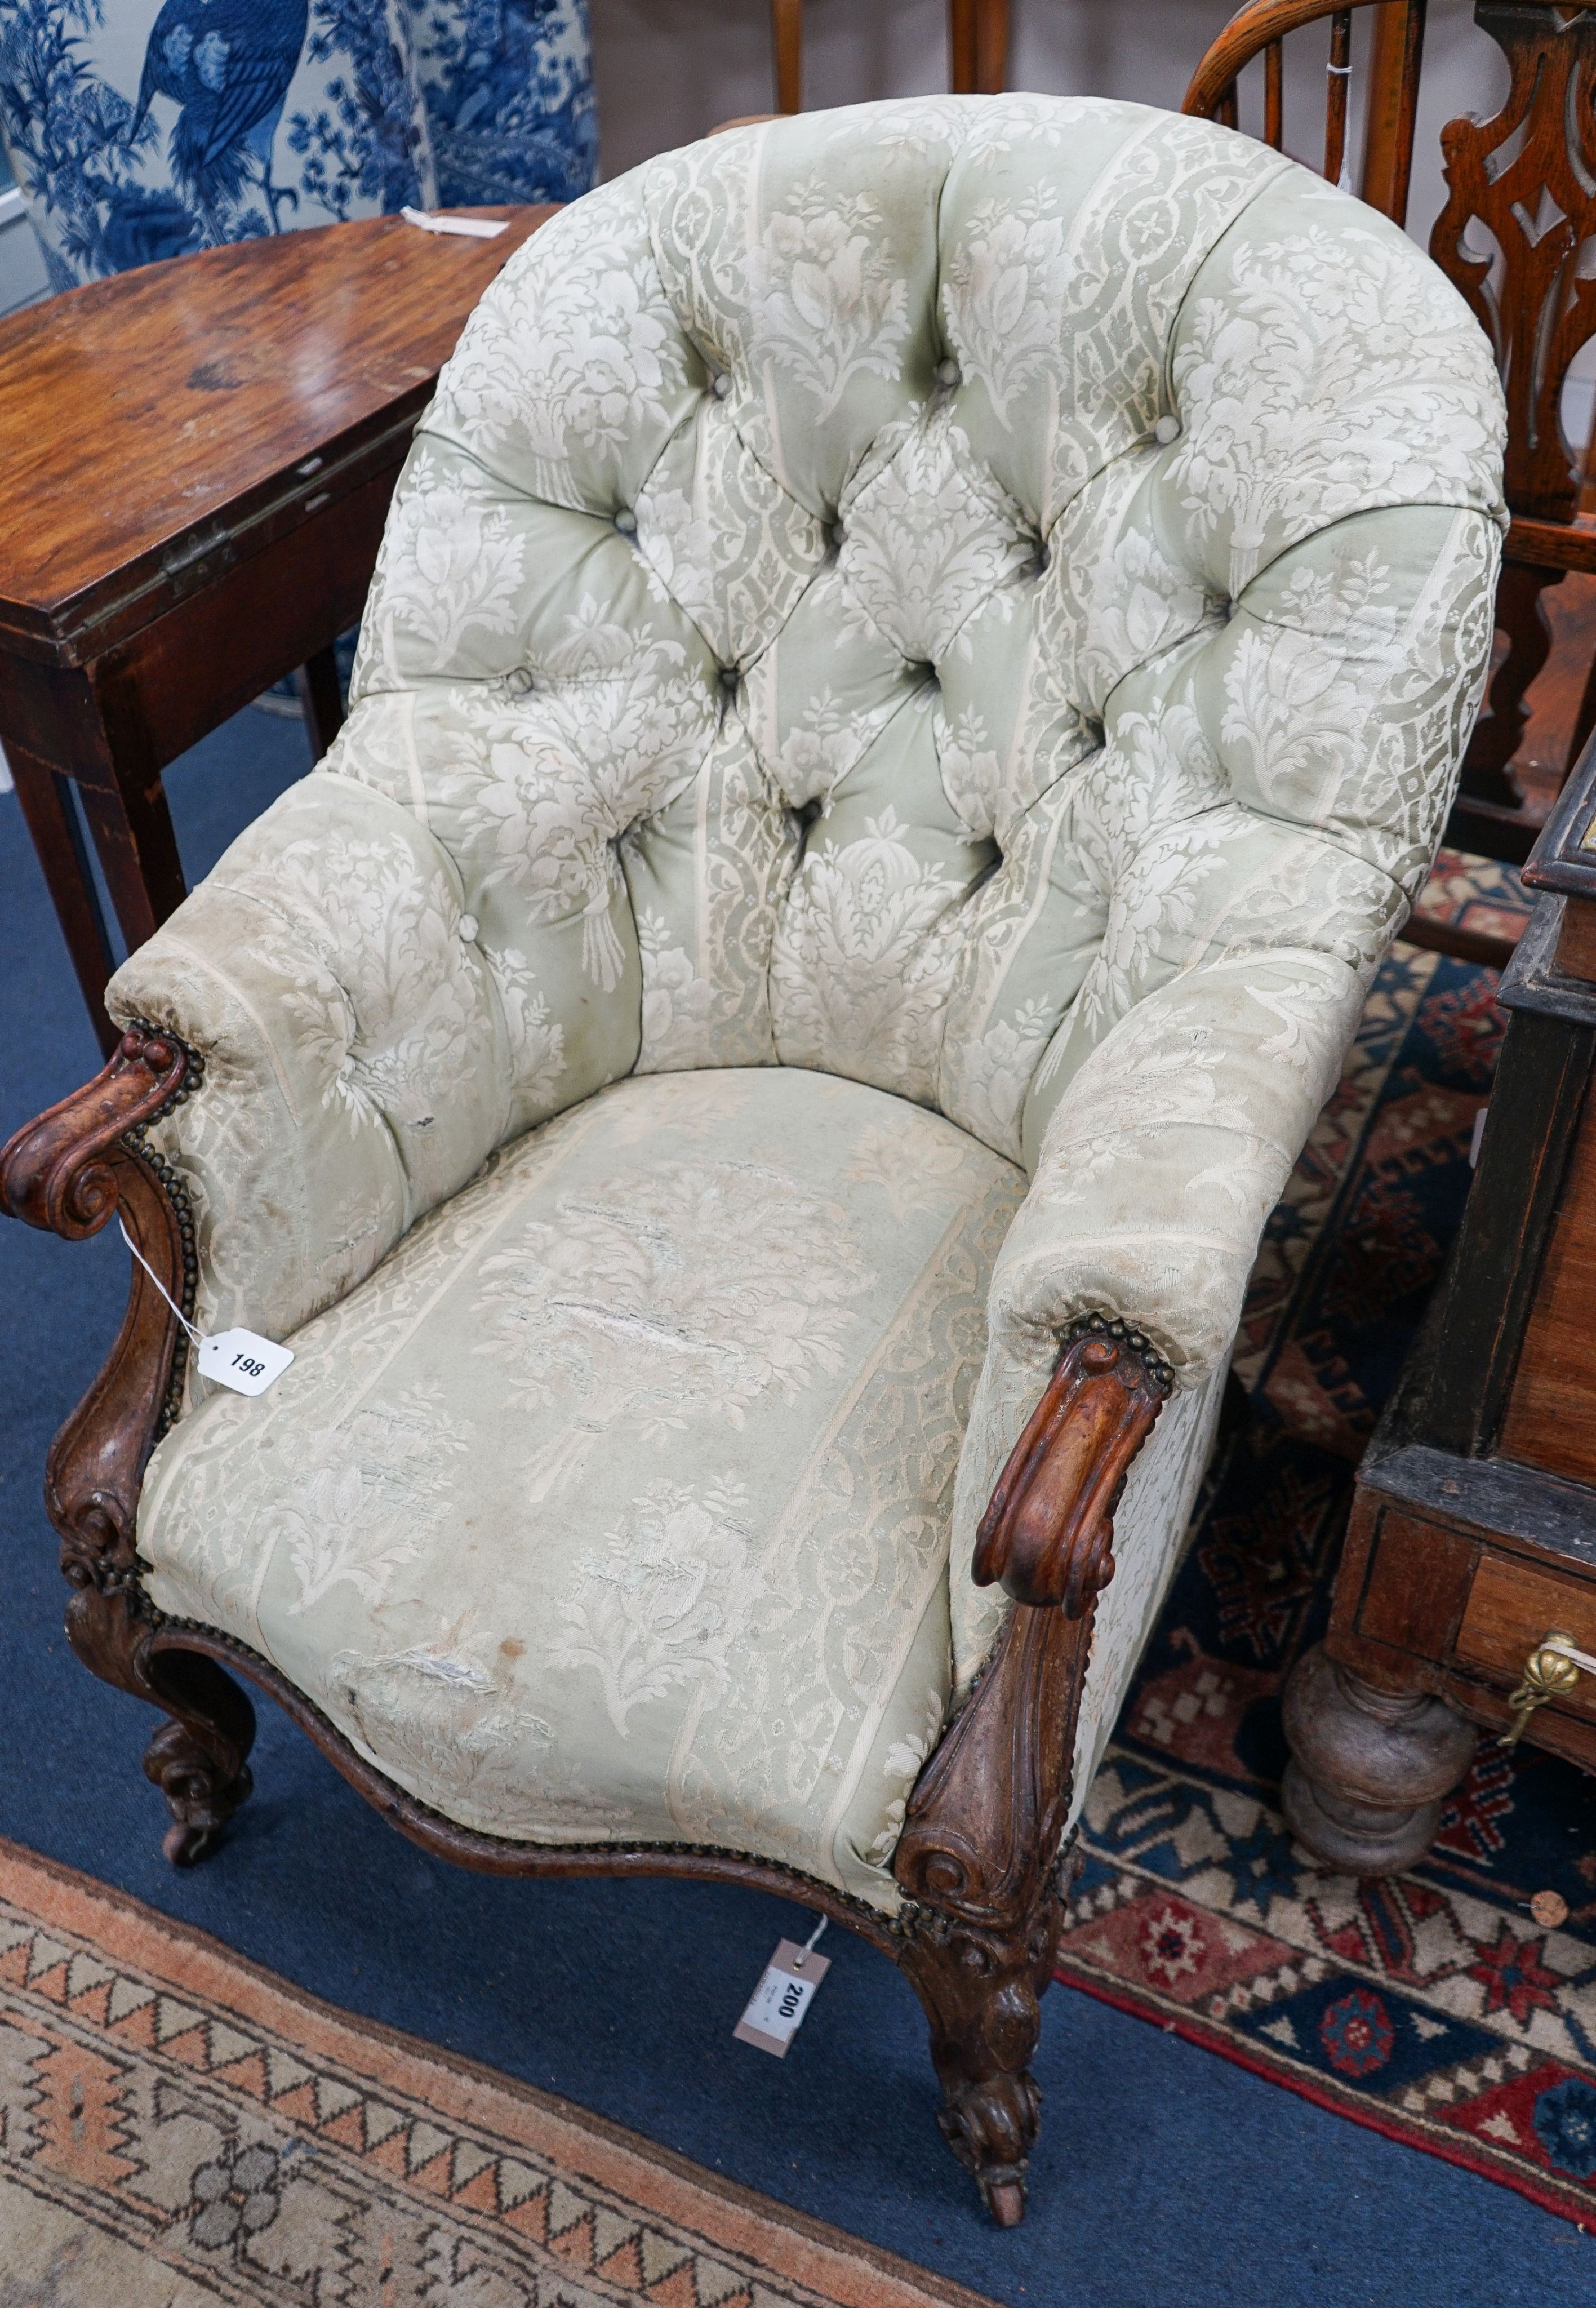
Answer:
[0,1842,989,2308]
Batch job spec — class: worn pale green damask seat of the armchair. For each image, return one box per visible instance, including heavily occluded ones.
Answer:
[139,1066,1024,1906]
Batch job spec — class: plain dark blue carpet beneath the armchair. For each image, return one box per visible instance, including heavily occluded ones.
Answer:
[0,711,1596,2308]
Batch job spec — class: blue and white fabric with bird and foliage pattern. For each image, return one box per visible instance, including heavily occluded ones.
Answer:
[0,0,597,288]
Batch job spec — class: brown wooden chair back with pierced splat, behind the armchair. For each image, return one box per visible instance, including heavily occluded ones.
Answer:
[1183,0,1596,868]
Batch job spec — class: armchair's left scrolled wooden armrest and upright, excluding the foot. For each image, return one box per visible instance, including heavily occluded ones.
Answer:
[0,1023,205,1588]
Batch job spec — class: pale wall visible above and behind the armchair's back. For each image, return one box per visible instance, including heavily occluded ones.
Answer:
[590,0,1508,238]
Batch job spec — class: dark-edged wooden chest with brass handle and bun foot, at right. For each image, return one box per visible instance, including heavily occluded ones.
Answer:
[1284,741,1596,1874]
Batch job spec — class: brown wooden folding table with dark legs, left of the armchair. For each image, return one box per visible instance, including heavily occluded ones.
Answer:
[0,208,554,1053]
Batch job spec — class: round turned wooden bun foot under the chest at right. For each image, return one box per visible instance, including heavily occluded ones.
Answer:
[1280,1643,1476,1876]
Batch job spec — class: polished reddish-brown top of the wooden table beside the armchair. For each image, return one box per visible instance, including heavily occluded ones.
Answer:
[0,208,551,663]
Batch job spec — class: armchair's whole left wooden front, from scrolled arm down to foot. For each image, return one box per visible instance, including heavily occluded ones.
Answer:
[0,1027,254,1867]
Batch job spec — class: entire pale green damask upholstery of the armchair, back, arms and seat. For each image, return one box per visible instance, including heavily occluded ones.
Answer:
[113,97,1504,1904]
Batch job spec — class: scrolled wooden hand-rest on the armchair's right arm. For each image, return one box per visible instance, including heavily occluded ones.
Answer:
[973,1313,1172,1618]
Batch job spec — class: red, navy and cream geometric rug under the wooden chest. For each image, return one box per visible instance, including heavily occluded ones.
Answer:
[1059,854,1596,2225]
